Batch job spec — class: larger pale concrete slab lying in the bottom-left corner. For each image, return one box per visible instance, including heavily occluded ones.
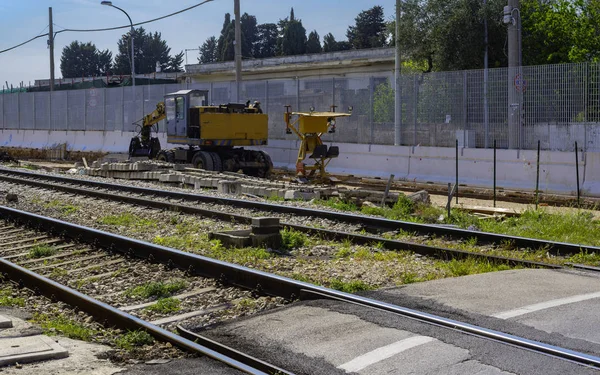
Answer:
[0,335,69,366]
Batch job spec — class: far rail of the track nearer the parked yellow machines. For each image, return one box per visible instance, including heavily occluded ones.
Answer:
[0,168,600,255]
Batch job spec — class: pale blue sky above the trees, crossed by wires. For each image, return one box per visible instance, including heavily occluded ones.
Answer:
[0,0,395,86]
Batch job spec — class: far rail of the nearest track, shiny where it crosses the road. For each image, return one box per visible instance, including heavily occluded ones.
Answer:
[0,206,600,367]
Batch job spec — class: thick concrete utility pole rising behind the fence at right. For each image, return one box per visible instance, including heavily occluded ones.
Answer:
[504,0,526,149]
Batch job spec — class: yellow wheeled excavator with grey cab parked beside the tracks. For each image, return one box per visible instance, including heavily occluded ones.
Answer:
[129,90,273,177]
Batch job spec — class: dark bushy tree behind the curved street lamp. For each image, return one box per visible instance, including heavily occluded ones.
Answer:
[115,27,183,74]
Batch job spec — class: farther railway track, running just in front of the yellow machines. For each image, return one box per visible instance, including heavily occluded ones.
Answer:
[0,168,600,267]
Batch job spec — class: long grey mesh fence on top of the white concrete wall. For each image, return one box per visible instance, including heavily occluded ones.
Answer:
[0,63,600,150]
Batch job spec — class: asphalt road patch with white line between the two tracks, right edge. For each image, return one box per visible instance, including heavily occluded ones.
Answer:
[381,269,600,350]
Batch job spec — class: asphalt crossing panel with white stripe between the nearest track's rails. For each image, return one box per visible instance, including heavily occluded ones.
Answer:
[209,306,508,375]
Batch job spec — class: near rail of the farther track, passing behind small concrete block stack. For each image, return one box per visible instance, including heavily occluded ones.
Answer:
[0,175,562,269]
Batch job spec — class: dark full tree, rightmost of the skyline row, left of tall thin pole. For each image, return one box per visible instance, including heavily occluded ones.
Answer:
[346,5,387,49]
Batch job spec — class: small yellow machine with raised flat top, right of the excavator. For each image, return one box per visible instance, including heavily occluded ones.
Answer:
[284,105,352,182]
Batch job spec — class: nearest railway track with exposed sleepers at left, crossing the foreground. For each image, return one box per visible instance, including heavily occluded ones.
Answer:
[0,206,600,374]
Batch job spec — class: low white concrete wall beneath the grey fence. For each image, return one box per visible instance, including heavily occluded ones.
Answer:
[0,130,600,197]
